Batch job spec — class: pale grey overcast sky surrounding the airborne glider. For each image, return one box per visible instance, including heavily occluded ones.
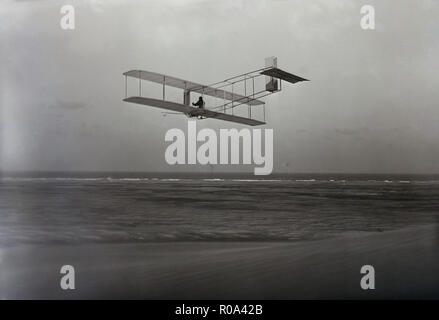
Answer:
[0,0,439,173]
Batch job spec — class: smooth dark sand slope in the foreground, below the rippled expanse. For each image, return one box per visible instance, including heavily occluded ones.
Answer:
[0,226,439,299]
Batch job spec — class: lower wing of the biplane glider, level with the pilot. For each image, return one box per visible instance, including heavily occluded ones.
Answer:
[123,97,265,126]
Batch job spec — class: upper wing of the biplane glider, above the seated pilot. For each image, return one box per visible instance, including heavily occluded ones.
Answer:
[124,70,264,106]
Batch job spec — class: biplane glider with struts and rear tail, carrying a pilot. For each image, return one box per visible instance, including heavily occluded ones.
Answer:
[123,57,309,126]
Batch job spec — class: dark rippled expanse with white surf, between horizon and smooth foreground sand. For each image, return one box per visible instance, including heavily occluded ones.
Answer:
[0,172,439,245]
